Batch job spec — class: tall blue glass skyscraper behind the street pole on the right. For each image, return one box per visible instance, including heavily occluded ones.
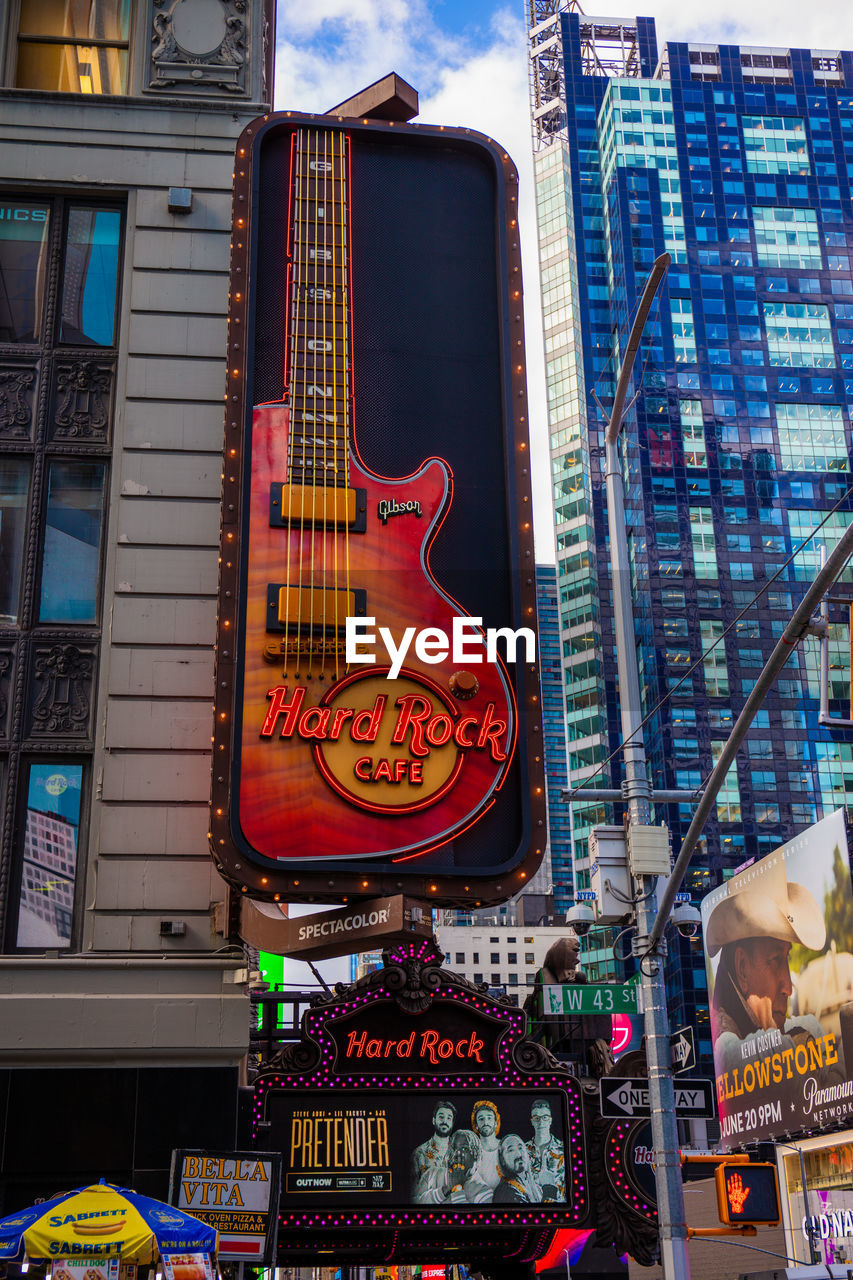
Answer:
[528,0,853,1052]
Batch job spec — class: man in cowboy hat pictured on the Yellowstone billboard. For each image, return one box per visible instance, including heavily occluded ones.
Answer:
[706,859,841,1080]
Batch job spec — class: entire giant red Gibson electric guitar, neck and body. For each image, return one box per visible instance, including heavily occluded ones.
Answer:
[240,127,514,859]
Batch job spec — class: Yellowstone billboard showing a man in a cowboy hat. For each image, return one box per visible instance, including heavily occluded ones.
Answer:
[702,810,853,1147]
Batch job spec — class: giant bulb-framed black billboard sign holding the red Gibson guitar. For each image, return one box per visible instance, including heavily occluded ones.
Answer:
[211,113,544,902]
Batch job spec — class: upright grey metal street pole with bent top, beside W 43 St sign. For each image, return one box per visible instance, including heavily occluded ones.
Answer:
[605,253,690,1280]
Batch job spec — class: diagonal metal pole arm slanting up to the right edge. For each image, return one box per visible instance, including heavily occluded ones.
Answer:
[648,525,853,946]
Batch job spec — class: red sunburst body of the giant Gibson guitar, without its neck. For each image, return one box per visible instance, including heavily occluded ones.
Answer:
[240,404,515,859]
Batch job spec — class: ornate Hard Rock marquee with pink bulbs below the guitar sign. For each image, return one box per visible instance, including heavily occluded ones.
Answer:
[254,942,656,1266]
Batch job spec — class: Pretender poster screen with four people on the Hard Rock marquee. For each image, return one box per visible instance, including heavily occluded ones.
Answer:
[268,1089,571,1207]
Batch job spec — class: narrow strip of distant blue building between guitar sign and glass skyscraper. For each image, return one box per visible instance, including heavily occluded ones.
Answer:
[537,564,575,920]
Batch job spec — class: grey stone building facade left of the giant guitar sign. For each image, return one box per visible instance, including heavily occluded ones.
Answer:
[0,0,274,1212]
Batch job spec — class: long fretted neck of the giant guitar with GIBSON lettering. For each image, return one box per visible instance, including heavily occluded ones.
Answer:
[286,129,352,486]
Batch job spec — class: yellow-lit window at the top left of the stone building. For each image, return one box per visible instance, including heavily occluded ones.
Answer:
[15,0,131,93]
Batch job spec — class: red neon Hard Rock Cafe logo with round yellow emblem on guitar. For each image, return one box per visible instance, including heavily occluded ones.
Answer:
[260,667,508,813]
